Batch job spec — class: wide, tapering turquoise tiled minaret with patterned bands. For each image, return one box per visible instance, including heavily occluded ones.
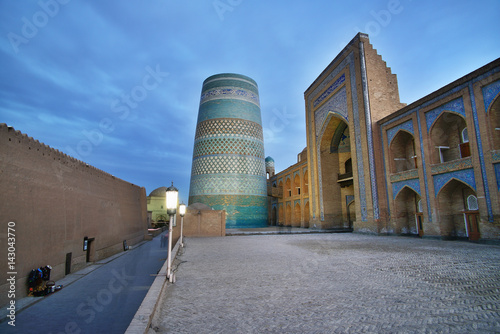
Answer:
[189,74,267,228]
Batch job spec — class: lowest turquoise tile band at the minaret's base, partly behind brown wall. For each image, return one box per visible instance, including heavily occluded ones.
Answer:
[189,195,267,228]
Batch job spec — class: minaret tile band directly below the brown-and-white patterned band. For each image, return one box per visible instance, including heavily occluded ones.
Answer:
[193,138,264,159]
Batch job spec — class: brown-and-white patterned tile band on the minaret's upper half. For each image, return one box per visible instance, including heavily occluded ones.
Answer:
[195,118,263,140]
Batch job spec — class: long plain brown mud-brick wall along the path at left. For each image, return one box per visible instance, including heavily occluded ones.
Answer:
[0,124,147,306]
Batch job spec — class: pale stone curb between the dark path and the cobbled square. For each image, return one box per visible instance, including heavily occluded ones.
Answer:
[125,241,180,334]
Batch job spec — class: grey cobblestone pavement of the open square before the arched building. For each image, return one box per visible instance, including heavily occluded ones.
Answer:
[150,234,500,333]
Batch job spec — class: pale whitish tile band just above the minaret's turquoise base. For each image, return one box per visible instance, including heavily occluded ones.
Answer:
[189,174,267,196]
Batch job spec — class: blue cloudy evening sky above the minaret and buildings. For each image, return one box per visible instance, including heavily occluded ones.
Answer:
[0,0,500,203]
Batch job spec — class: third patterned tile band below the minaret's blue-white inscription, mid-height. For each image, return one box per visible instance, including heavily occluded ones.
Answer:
[191,155,266,177]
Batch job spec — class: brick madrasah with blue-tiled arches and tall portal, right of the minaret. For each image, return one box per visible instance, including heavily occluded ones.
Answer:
[268,33,500,241]
